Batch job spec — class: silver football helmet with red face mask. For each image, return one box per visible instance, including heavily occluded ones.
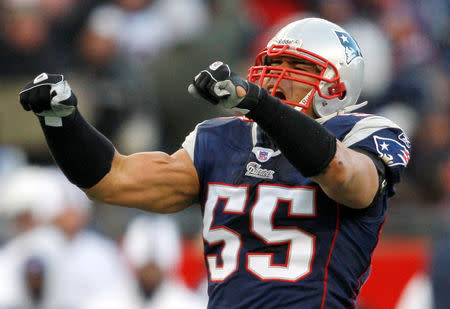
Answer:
[247,18,364,117]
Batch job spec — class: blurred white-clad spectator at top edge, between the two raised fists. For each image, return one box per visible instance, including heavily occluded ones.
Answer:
[107,0,208,65]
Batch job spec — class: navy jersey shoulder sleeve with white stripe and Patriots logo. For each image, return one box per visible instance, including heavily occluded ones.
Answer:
[325,115,411,196]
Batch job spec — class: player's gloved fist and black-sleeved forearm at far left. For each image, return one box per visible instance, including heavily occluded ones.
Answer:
[19,73,114,188]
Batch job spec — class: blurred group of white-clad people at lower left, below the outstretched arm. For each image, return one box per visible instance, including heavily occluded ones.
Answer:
[0,166,206,309]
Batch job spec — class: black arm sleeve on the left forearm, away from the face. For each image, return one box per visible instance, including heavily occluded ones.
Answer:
[39,109,115,189]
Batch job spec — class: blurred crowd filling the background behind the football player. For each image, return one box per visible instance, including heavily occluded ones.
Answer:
[0,0,450,308]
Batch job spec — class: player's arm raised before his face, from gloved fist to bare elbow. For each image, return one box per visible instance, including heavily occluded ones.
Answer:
[189,62,380,208]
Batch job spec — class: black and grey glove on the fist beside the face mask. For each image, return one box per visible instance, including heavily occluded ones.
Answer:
[188,61,260,109]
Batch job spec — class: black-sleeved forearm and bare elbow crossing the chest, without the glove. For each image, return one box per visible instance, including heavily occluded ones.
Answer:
[244,88,378,208]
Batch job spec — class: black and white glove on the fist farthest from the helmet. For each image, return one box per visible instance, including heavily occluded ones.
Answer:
[19,73,77,125]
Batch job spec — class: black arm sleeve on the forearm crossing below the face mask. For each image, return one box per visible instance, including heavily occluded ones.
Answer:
[239,83,336,177]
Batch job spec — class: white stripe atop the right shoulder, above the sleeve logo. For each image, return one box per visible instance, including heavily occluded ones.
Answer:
[342,116,401,147]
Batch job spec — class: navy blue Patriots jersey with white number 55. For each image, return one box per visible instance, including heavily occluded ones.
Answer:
[183,114,409,309]
